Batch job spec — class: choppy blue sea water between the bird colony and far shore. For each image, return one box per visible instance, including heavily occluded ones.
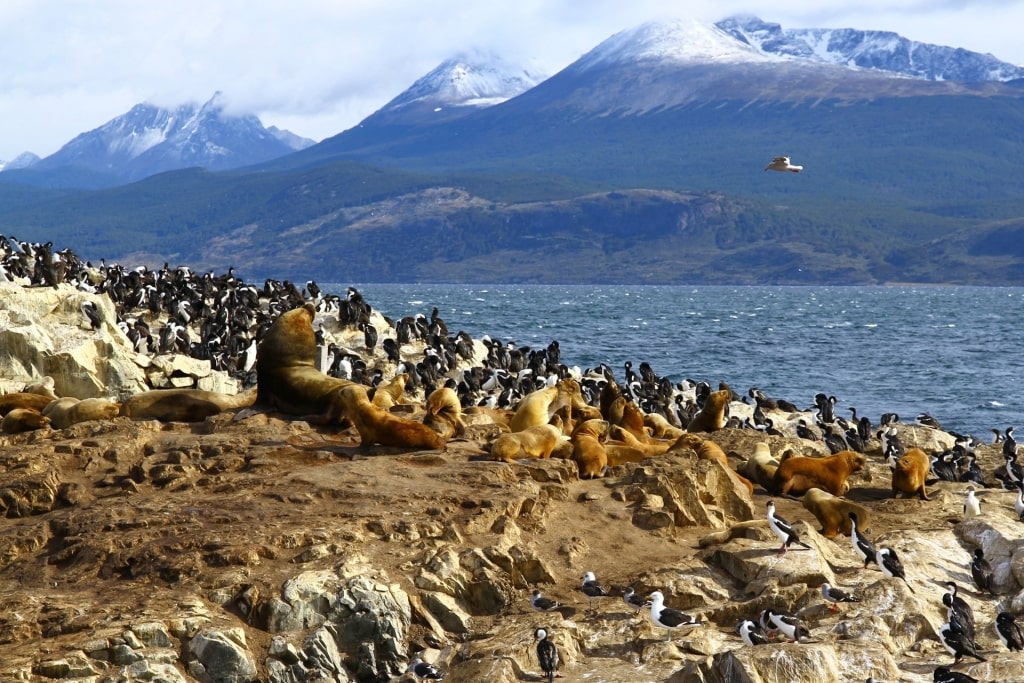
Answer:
[325,284,1024,441]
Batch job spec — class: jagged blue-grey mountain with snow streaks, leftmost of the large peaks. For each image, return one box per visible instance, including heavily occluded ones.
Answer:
[33,94,313,180]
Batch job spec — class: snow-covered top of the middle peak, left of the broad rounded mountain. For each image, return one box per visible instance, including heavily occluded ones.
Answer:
[371,50,547,123]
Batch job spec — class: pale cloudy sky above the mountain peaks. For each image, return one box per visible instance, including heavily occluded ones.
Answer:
[0,0,1024,160]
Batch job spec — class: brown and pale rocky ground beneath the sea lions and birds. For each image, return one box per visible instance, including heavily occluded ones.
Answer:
[0,253,1024,683]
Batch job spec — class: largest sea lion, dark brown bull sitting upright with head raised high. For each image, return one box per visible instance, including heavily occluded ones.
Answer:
[256,303,352,423]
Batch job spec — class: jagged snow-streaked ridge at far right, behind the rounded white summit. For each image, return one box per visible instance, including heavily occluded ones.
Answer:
[715,16,1024,83]
